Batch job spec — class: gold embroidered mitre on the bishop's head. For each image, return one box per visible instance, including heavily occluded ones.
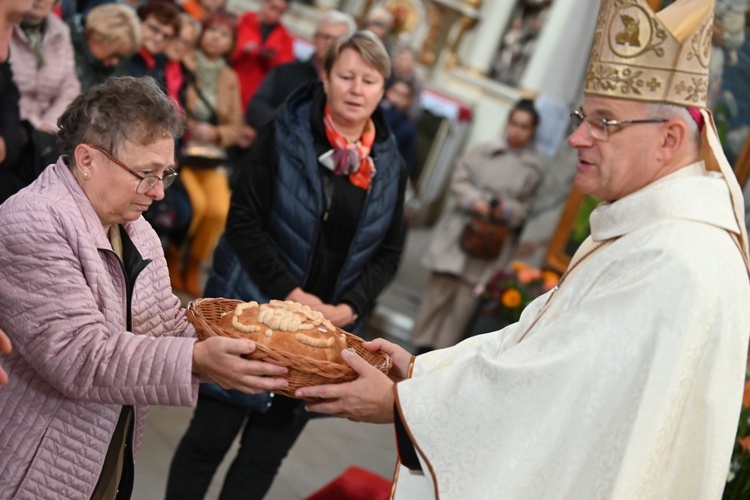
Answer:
[585,0,714,108]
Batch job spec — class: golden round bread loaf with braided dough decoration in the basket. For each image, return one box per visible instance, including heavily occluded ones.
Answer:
[219,300,347,363]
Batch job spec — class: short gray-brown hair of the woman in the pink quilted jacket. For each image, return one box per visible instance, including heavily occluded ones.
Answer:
[57,76,184,162]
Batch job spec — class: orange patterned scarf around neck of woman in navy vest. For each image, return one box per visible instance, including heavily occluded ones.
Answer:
[321,104,375,189]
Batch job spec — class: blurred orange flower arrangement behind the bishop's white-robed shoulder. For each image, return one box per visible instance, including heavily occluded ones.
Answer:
[480,261,560,323]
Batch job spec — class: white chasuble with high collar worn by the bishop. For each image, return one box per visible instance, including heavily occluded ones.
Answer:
[395,163,750,500]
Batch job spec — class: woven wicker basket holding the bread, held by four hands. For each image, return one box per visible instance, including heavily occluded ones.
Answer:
[186,299,392,397]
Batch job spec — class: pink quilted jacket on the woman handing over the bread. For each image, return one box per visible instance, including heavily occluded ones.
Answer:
[0,161,198,499]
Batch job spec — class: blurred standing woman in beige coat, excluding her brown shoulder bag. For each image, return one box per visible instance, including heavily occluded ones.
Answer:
[412,100,542,353]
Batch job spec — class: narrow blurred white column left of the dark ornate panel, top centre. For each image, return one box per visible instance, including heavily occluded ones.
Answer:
[460,0,517,73]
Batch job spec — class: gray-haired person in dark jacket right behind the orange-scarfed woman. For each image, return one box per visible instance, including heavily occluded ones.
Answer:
[241,10,357,147]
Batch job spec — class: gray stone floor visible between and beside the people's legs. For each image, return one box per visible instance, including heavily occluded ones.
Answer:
[133,228,429,500]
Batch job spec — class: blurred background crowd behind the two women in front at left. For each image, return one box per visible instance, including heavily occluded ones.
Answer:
[0,0,422,297]
